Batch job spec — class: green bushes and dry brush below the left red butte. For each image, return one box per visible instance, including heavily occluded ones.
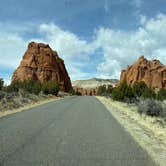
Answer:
[0,79,60,111]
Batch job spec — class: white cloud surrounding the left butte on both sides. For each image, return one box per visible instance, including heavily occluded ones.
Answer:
[0,23,95,80]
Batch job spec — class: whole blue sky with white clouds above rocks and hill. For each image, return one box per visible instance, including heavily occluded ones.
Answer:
[0,0,166,83]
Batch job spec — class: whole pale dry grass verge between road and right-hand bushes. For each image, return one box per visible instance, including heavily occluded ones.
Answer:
[97,97,166,166]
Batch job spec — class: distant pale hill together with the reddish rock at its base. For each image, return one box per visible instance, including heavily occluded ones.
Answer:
[72,78,118,96]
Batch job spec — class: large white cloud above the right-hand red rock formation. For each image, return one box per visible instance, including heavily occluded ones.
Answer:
[95,14,166,78]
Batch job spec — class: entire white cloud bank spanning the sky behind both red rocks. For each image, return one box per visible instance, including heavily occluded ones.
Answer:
[0,14,166,83]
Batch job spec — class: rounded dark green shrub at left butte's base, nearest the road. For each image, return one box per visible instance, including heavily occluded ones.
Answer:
[42,81,59,95]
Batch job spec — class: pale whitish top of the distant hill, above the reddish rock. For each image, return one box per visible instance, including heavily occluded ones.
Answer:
[72,78,119,88]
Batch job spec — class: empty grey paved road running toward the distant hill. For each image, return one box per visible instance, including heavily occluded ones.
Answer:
[0,97,154,166]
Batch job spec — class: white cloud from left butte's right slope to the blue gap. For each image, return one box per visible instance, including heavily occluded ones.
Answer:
[36,23,95,80]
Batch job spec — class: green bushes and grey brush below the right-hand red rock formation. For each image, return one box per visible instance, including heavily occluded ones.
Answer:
[98,81,166,118]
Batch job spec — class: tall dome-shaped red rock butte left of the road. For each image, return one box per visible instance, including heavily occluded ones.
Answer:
[12,42,72,92]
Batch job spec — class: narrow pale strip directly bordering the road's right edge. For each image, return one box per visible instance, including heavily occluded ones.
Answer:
[96,96,166,166]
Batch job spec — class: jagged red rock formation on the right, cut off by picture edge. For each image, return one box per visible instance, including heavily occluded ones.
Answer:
[120,56,166,89]
